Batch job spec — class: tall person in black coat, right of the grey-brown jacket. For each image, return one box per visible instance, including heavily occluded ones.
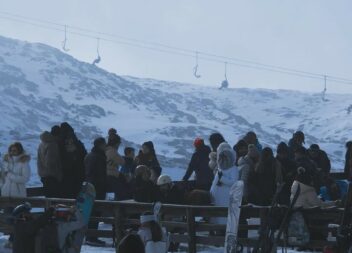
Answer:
[60,122,87,199]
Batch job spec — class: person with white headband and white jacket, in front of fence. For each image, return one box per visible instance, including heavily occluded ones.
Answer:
[138,213,169,253]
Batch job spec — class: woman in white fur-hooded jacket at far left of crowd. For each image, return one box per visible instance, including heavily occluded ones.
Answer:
[1,142,30,197]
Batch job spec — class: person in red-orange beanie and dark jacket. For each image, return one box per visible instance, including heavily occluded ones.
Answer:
[183,138,214,191]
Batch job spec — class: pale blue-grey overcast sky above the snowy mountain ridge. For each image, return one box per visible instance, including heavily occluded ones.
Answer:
[0,0,352,93]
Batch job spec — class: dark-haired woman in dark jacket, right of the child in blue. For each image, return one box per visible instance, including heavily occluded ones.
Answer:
[135,141,162,183]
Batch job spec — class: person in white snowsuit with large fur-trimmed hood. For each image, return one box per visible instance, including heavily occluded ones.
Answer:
[210,142,238,224]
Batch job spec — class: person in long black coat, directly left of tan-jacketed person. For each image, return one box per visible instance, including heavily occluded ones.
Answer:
[84,137,107,246]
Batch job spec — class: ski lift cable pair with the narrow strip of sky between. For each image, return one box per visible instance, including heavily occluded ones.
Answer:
[0,11,352,84]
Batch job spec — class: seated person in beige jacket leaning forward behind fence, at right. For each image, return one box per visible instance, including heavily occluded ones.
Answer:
[291,167,339,208]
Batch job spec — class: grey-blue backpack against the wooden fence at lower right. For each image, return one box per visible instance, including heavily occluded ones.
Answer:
[287,211,310,246]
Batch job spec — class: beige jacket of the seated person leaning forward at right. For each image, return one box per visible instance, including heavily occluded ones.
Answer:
[291,180,335,208]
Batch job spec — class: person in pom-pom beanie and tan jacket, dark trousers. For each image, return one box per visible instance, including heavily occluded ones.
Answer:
[105,128,131,200]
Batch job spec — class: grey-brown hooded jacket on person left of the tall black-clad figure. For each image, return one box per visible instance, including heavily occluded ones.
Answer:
[37,131,63,182]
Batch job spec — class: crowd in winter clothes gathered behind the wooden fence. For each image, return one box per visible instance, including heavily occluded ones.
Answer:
[0,122,352,249]
